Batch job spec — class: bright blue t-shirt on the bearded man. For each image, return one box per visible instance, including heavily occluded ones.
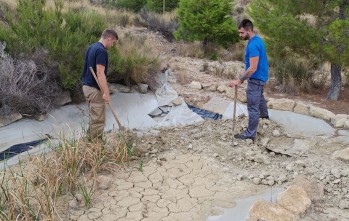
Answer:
[245,35,268,82]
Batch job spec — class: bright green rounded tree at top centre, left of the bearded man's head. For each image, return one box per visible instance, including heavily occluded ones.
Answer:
[175,0,239,50]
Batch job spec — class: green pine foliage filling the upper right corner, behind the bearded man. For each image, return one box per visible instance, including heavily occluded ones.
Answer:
[249,0,349,66]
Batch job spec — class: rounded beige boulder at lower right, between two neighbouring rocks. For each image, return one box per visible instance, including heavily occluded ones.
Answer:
[277,185,311,215]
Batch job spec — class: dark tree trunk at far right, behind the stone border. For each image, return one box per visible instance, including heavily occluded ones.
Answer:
[327,64,342,101]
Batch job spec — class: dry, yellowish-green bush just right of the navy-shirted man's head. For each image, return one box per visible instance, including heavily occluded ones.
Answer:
[108,33,160,85]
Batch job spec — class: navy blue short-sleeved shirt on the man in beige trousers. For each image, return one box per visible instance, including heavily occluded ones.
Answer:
[82,42,108,89]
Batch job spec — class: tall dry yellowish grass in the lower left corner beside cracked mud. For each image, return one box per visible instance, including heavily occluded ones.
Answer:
[0,131,134,218]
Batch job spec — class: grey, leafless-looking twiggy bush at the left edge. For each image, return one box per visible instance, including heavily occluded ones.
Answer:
[0,43,61,116]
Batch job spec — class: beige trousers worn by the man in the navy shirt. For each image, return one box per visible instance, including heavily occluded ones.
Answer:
[82,85,105,139]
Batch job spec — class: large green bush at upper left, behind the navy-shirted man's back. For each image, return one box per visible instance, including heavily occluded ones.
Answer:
[0,0,105,91]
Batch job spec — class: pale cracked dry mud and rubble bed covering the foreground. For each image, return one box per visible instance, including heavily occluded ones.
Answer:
[59,118,349,221]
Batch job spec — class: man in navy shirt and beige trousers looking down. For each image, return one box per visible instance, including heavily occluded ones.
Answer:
[82,29,118,139]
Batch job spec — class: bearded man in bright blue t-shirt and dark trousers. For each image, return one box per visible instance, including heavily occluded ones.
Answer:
[230,19,269,141]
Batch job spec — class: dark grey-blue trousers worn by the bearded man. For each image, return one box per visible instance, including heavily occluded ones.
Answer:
[244,79,268,137]
